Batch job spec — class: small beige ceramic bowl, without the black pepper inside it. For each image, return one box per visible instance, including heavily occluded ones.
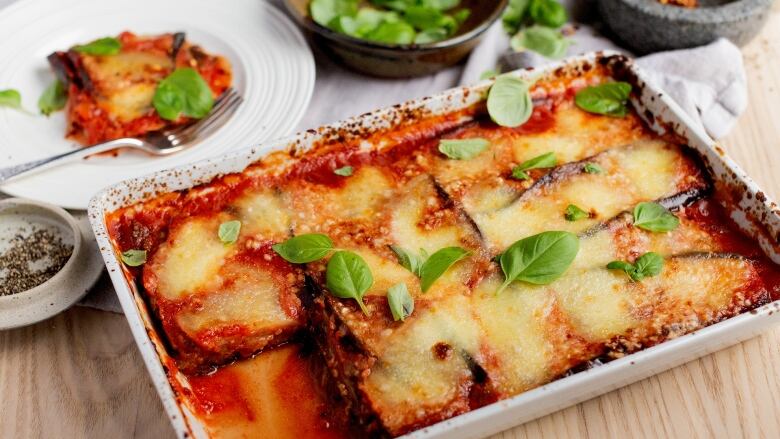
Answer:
[0,198,97,329]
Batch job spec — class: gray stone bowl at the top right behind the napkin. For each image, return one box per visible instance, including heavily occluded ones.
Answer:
[597,0,773,54]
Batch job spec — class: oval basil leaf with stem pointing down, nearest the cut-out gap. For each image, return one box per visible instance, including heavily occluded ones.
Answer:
[325,250,374,314]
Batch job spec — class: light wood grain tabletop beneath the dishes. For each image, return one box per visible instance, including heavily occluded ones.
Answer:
[0,2,780,438]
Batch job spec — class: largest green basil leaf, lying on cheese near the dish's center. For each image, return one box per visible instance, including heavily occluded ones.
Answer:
[496,231,580,294]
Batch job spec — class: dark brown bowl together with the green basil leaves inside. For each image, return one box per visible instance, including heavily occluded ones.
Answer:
[284,0,508,78]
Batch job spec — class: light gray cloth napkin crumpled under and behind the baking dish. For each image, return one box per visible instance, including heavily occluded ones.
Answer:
[68,0,747,312]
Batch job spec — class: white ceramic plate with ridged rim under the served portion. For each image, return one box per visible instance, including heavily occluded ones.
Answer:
[0,0,315,209]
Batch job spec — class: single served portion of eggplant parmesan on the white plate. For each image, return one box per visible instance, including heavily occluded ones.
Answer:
[48,32,232,145]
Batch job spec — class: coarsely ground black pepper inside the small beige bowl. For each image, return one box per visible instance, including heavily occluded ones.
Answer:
[0,229,73,296]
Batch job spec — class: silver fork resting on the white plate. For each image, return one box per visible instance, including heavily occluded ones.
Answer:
[0,88,243,183]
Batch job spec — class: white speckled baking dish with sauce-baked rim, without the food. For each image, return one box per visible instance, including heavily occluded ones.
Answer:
[89,53,780,438]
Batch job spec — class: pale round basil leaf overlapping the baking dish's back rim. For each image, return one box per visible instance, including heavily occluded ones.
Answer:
[487,76,534,128]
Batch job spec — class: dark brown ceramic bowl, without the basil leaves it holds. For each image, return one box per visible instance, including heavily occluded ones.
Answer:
[284,0,508,78]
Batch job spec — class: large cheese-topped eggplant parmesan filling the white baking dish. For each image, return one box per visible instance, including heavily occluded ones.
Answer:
[107,60,780,437]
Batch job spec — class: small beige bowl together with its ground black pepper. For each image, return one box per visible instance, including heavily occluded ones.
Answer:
[0,198,92,329]
